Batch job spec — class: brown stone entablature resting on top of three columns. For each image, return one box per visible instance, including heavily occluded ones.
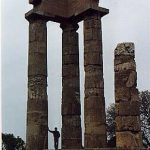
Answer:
[26,0,109,23]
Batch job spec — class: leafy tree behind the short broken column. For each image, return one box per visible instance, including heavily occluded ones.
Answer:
[106,91,150,148]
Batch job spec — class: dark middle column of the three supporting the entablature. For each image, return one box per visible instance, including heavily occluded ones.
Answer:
[61,23,82,149]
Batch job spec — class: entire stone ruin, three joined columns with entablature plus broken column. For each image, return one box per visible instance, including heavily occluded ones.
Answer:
[25,0,142,150]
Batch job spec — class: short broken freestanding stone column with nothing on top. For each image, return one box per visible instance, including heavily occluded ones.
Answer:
[114,43,142,148]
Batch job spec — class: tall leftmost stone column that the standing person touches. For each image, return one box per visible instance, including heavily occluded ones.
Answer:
[26,18,48,150]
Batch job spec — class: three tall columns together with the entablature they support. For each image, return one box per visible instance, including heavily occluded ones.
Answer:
[25,0,108,150]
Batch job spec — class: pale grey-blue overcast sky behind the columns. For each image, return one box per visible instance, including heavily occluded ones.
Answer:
[1,0,150,148]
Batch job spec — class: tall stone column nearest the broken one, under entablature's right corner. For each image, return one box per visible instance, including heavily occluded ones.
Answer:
[84,14,107,148]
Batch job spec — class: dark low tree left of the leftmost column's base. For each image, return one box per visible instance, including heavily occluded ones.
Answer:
[2,133,25,150]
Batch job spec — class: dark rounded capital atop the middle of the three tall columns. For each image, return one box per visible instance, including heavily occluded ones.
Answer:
[60,22,79,31]
